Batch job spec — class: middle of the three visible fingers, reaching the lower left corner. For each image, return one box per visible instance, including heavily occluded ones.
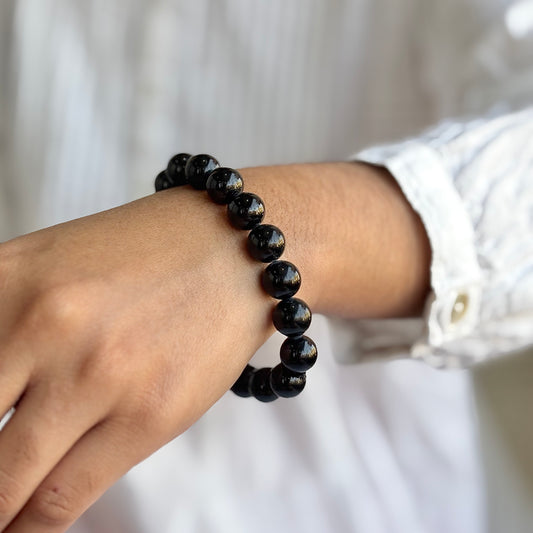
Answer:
[0,384,107,531]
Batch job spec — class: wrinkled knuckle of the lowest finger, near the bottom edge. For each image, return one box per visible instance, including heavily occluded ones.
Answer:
[28,485,81,526]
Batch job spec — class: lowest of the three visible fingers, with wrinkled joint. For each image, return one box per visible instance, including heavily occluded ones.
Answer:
[4,419,149,533]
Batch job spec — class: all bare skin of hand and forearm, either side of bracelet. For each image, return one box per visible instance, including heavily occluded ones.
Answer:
[0,163,430,533]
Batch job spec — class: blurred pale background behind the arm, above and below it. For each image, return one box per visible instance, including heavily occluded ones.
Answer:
[0,0,533,533]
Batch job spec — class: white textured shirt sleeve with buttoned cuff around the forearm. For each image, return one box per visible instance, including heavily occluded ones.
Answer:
[331,108,533,367]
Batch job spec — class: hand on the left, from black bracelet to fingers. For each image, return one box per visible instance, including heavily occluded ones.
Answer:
[0,189,282,533]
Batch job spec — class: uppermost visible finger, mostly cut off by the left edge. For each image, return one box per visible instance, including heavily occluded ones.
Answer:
[0,340,32,420]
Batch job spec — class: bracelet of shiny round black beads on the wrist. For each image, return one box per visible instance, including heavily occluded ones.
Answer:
[155,154,318,402]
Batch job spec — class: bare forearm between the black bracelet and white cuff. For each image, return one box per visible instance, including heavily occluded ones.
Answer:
[242,163,431,318]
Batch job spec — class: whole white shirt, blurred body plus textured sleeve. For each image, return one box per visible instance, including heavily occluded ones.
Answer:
[0,0,533,533]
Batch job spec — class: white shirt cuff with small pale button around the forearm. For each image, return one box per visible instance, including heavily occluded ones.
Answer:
[330,140,483,368]
